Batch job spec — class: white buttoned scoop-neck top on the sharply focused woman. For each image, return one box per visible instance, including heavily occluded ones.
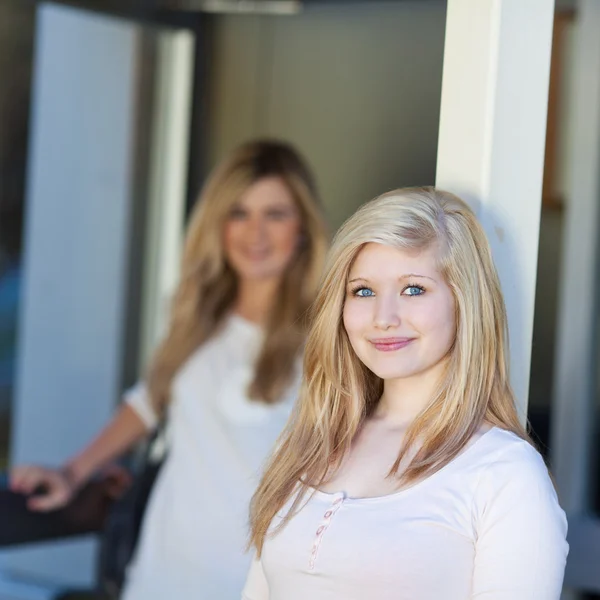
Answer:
[242,428,568,600]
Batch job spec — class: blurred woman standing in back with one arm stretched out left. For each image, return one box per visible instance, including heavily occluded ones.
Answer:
[11,141,327,600]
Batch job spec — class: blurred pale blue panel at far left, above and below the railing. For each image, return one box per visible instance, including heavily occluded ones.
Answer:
[3,4,138,585]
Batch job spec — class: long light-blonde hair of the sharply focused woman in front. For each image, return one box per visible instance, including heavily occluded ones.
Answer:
[250,188,529,555]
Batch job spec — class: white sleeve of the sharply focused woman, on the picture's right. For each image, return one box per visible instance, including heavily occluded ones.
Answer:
[472,442,569,600]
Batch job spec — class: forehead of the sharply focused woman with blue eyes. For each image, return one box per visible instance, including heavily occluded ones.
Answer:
[348,243,440,280]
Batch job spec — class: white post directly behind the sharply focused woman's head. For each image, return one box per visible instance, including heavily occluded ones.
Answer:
[436,0,554,420]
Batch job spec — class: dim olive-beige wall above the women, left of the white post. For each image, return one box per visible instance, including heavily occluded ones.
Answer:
[209,0,446,228]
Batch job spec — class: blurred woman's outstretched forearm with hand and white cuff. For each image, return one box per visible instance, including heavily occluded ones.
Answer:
[10,386,155,511]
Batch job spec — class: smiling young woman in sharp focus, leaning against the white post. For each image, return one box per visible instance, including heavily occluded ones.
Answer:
[243,188,568,600]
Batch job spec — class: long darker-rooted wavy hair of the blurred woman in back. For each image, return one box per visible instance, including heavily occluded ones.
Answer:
[148,140,328,411]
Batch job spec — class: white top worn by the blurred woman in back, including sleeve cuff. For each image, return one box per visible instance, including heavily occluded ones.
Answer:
[123,316,300,600]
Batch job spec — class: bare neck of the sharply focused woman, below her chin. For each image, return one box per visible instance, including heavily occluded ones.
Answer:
[374,363,445,428]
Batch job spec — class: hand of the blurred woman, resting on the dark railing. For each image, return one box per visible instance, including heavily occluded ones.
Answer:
[9,465,76,512]
